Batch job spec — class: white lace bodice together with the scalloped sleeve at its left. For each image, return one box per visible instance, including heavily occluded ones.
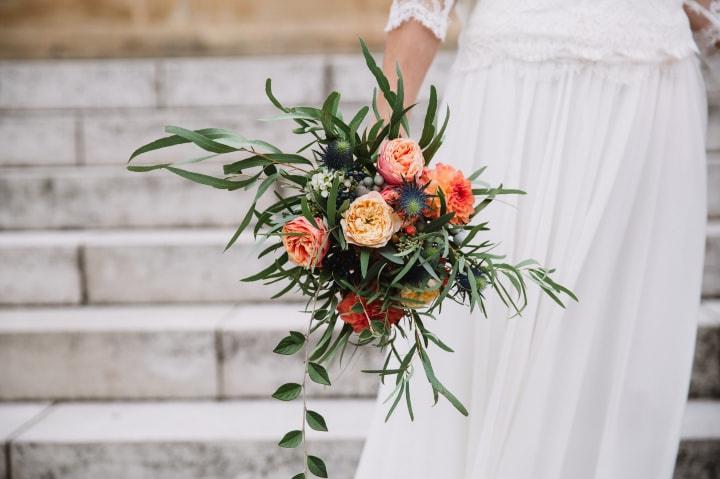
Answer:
[386,0,697,68]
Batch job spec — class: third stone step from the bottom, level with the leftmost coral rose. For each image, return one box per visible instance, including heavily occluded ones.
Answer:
[0,227,720,305]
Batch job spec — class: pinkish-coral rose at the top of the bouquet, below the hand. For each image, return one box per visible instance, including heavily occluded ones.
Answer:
[377,138,425,186]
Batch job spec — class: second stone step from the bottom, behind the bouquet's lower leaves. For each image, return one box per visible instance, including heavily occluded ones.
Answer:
[0,301,720,400]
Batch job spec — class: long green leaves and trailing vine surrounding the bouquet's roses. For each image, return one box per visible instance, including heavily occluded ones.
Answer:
[127,40,577,479]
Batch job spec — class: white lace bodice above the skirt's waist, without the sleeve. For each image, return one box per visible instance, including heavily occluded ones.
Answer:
[457,0,697,69]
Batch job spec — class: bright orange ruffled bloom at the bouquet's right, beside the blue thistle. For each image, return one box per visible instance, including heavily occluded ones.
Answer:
[420,163,475,225]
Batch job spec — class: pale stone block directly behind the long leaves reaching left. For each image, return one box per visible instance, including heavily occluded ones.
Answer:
[81,106,306,165]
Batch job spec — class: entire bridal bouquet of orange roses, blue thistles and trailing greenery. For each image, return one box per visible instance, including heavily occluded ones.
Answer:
[128,41,575,479]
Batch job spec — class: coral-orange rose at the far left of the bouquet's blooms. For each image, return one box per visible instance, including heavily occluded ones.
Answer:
[282,216,330,268]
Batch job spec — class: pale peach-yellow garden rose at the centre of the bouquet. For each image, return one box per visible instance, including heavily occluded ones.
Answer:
[340,191,402,248]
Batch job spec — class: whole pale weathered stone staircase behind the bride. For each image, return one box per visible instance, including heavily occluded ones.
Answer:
[0,54,720,479]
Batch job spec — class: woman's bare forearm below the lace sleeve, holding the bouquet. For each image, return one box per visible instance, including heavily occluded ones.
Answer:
[379,20,440,114]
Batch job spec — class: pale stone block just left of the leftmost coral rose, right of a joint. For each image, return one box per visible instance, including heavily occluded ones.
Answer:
[85,230,281,303]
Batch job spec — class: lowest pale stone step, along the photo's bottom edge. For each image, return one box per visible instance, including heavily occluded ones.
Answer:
[0,400,720,479]
